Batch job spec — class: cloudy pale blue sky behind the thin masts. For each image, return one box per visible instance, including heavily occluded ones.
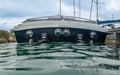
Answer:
[0,0,120,31]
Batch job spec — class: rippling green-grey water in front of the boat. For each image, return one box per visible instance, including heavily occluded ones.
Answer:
[0,42,120,75]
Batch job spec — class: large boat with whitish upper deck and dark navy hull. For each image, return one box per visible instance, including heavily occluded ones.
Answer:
[14,0,107,43]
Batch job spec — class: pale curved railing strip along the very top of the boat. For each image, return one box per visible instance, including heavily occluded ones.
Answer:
[23,15,96,23]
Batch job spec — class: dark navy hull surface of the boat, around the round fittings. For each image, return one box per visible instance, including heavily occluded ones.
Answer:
[15,28,106,43]
